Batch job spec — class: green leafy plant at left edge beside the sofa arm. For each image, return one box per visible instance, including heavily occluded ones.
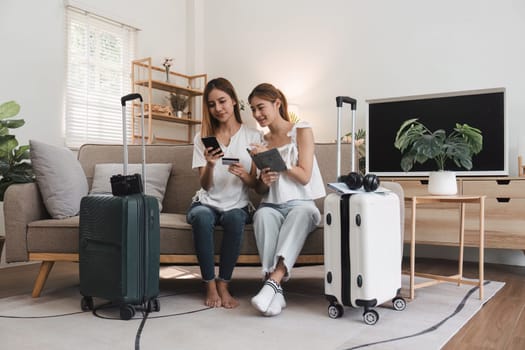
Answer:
[0,101,35,201]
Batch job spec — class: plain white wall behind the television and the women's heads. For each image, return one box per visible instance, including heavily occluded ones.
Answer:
[197,0,525,265]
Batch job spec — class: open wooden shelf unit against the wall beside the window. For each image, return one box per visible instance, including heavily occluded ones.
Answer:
[131,57,207,144]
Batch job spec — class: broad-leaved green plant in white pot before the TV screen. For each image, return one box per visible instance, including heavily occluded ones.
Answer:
[394,118,483,195]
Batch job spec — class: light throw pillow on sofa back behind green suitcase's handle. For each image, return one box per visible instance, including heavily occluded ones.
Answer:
[90,163,172,211]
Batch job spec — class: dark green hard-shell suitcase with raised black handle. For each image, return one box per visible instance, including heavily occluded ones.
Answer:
[79,94,160,320]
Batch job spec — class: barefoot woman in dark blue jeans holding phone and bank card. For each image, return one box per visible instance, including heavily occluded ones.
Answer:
[186,78,261,308]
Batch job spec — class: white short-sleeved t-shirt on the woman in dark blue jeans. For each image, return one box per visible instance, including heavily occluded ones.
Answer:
[192,125,262,211]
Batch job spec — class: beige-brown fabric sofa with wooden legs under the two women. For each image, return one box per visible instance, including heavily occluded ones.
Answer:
[4,144,404,297]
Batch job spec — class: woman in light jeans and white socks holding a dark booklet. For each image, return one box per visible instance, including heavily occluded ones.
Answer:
[248,83,326,316]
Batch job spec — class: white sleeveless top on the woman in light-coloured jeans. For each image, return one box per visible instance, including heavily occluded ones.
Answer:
[262,121,326,204]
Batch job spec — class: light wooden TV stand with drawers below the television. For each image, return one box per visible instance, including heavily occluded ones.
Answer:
[381,177,525,253]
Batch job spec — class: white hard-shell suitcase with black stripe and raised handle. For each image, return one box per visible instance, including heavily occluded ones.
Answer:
[324,97,406,325]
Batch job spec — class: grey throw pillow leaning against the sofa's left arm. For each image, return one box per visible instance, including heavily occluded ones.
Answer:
[29,140,89,219]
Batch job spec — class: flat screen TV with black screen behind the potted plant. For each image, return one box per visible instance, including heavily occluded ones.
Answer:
[366,88,508,176]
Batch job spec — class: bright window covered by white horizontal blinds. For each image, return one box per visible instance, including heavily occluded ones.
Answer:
[65,7,136,148]
